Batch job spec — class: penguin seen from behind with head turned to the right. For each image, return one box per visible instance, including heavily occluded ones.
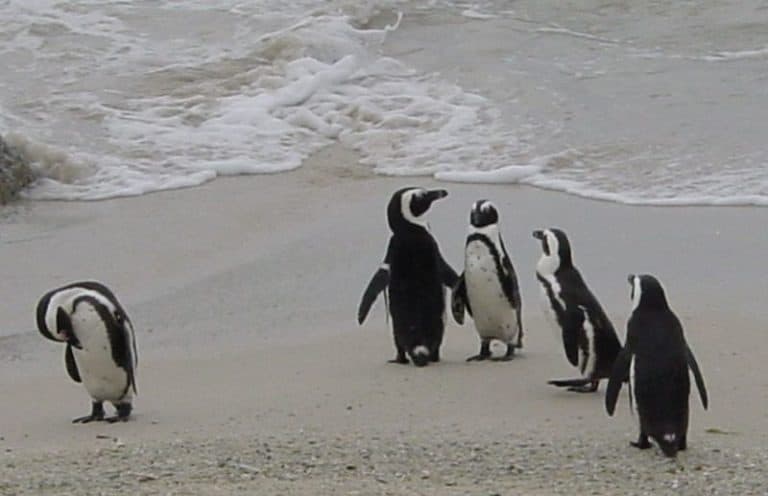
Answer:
[357,187,457,367]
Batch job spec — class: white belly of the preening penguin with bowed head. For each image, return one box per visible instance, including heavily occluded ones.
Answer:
[73,335,131,401]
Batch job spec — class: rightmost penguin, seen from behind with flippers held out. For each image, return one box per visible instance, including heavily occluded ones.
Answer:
[605,275,709,457]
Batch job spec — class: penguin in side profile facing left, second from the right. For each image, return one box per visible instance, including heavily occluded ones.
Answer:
[533,229,621,393]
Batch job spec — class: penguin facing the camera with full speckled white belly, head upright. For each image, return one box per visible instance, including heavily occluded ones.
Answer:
[451,200,523,361]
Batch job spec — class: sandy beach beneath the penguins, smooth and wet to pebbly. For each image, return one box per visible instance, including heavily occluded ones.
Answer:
[0,147,768,495]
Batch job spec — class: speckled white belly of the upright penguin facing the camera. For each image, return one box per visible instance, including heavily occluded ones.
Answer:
[464,241,517,343]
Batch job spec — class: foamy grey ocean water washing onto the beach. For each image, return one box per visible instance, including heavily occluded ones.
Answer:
[0,0,768,205]
